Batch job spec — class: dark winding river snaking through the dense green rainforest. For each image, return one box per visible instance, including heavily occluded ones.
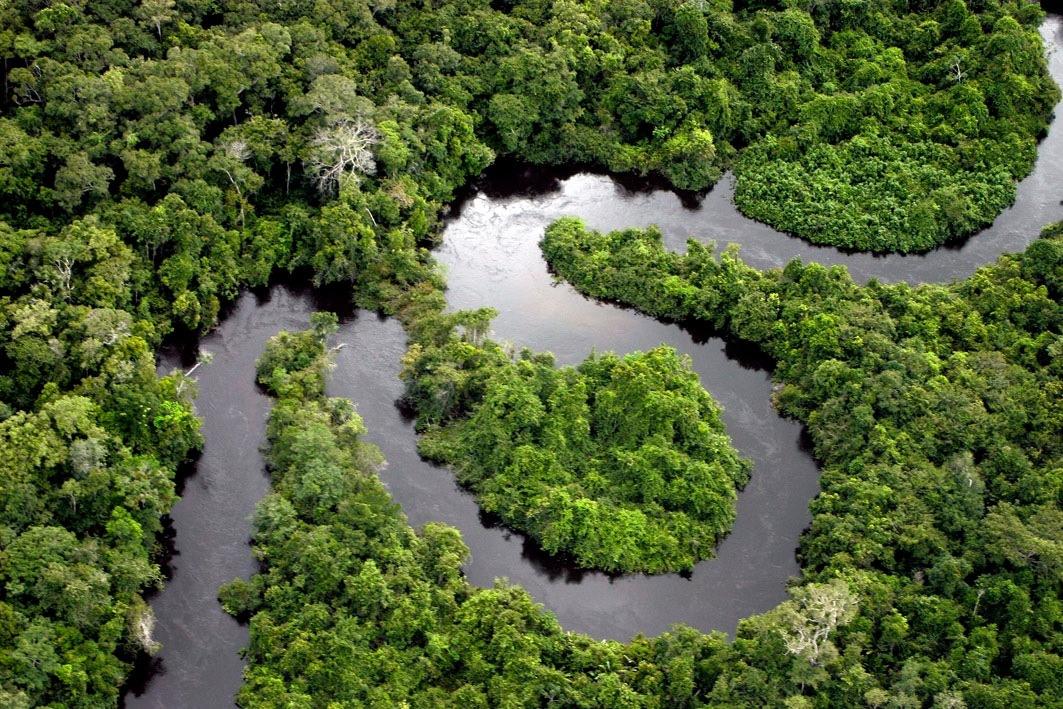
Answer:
[124,15,1063,709]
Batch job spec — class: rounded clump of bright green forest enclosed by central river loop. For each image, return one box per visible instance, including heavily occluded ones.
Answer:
[403,336,749,572]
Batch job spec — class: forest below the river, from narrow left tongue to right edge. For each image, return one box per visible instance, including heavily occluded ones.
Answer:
[221,213,1063,708]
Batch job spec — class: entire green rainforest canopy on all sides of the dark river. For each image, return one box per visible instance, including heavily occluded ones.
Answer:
[0,0,1063,708]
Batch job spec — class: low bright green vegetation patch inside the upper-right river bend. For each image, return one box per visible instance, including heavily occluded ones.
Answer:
[735,132,1028,252]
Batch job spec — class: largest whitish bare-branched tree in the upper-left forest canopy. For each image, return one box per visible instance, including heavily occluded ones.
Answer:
[307,118,379,195]
